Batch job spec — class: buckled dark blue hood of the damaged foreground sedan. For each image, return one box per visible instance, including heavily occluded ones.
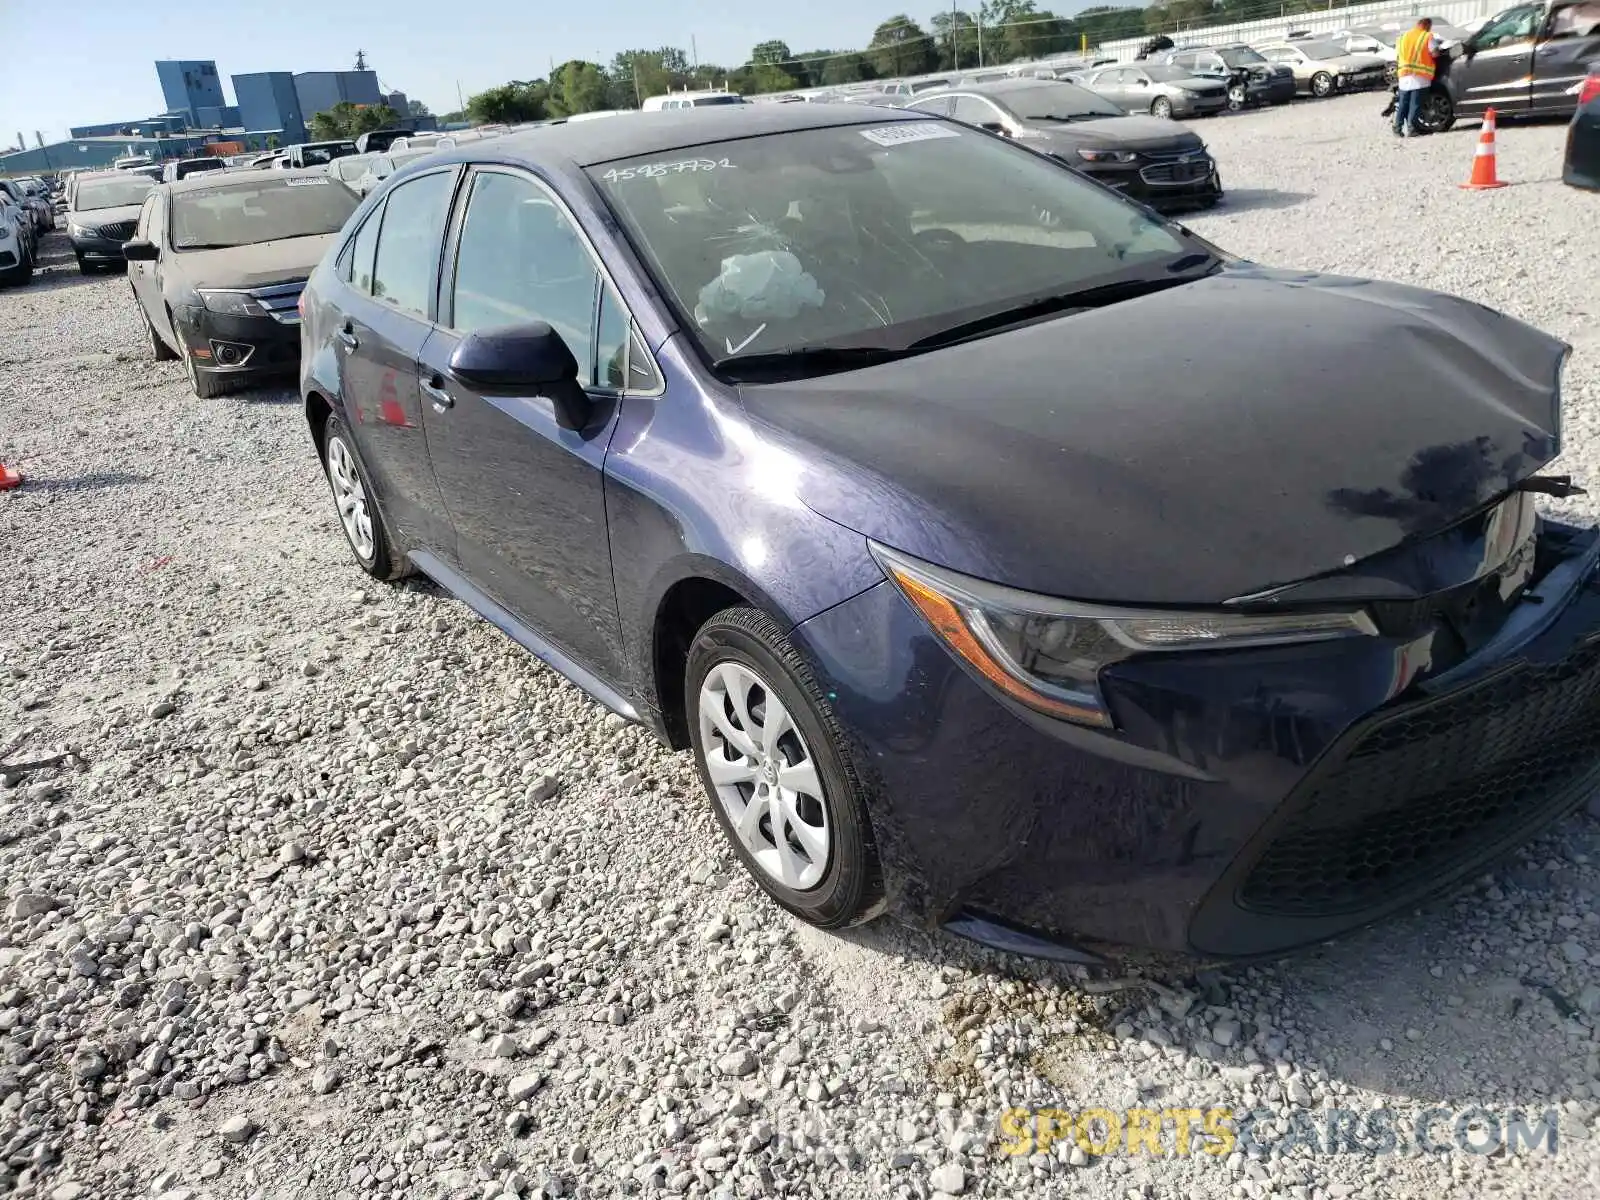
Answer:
[741,266,1568,605]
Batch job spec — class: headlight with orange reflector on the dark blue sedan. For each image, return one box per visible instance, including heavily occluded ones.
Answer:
[872,542,1378,728]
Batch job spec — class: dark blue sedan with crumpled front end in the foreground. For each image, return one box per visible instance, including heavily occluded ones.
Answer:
[301,104,1600,960]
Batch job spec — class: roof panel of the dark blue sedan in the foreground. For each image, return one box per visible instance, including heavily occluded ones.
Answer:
[438,104,936,166]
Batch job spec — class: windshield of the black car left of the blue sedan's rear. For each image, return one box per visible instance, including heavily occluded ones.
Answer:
[173,176,360,250]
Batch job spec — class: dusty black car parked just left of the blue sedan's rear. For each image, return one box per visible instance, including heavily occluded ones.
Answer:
[125,170,358,398]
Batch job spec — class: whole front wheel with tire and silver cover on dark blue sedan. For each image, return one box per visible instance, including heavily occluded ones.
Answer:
[685,608,883,930]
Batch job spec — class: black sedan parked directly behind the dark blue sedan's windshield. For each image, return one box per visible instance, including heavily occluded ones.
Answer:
[906,78,1222,208]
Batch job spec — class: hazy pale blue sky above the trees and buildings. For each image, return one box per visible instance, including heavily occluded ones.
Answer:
[0,0,960,146]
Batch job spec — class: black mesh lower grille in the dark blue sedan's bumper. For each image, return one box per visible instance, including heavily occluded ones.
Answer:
[1238,642,1600,917]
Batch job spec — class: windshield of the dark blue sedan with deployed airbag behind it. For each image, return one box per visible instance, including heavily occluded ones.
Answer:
[589,120,1190,369]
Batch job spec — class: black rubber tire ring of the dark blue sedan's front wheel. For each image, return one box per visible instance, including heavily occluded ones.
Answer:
[685,608,883,930]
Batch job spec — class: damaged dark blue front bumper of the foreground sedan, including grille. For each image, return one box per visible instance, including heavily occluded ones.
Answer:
[797,522,1600,962]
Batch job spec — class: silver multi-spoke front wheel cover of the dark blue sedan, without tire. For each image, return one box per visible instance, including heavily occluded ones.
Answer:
[699,661,834,891]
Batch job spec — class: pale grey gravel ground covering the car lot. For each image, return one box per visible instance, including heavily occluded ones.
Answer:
[0,96,1600,1200]
